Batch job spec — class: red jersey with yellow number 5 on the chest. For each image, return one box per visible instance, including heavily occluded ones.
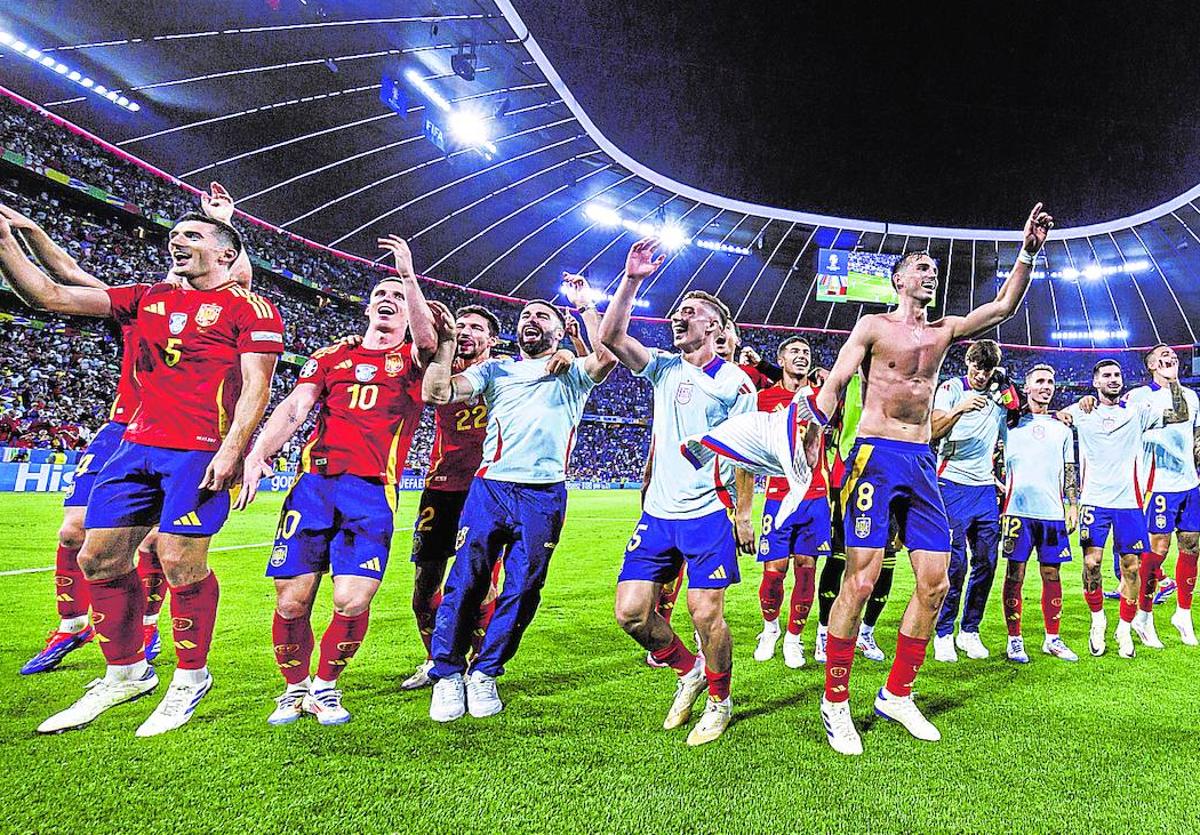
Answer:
[108,282,283,450]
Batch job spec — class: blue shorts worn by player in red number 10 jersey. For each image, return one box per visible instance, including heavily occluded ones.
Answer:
[266,473,396,579]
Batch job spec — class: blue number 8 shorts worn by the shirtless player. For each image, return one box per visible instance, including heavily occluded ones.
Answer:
[841,438,950,552]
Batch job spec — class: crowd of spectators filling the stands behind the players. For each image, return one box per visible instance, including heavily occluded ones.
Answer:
[0,98,1180,472]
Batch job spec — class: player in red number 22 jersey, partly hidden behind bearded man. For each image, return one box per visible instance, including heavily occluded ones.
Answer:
[400,305,500,690]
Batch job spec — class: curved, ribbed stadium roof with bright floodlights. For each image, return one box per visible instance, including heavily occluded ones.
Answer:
[0,0,1200,346]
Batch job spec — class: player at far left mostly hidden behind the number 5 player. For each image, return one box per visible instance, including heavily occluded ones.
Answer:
[0,205,166,675]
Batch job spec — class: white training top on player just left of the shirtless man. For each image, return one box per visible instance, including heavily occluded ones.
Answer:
[637,348,758,519]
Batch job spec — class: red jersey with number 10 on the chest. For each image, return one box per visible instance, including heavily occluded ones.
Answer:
[300,344,425,485]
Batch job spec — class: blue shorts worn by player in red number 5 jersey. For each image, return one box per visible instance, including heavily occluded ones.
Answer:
[84,440,229,536]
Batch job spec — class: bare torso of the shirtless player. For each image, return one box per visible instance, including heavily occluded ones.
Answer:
[858,313,954,443]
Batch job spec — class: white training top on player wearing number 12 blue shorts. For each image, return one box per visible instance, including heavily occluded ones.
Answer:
[1003,414,1075,522]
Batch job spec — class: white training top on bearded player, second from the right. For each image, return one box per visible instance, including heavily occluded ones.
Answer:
[1067,403,1163,509]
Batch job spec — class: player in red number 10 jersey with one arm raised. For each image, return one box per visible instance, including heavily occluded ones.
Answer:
[236,236,437,725]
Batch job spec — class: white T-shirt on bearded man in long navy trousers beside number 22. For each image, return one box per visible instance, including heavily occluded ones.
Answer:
[462,356,595,485]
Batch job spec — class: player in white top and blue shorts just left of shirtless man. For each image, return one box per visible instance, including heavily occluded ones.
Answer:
[600,238,756,745]
